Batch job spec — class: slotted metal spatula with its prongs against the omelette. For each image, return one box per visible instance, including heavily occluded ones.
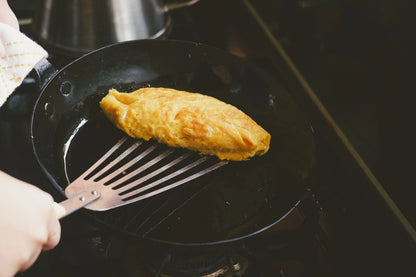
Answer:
[55,137,227,218]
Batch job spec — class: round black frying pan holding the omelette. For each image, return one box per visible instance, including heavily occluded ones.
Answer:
[31,40,315,246]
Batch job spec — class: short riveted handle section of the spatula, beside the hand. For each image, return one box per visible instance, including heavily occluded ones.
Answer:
[54,191,100,219]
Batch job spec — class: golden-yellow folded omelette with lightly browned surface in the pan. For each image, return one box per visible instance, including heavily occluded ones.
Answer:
[100,88,270,161]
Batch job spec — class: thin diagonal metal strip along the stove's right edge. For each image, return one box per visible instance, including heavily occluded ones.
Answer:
[241,0,416,243]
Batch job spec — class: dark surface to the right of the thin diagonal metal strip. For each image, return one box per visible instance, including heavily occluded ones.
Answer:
[247,0,416,225]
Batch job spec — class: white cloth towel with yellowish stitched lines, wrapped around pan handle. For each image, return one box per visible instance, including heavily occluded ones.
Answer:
[0,23,48,107]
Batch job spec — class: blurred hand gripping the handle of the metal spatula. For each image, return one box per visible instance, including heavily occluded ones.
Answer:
[0,171,61,276]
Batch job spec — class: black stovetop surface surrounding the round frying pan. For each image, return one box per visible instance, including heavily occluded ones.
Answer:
[0,0,416,277]
